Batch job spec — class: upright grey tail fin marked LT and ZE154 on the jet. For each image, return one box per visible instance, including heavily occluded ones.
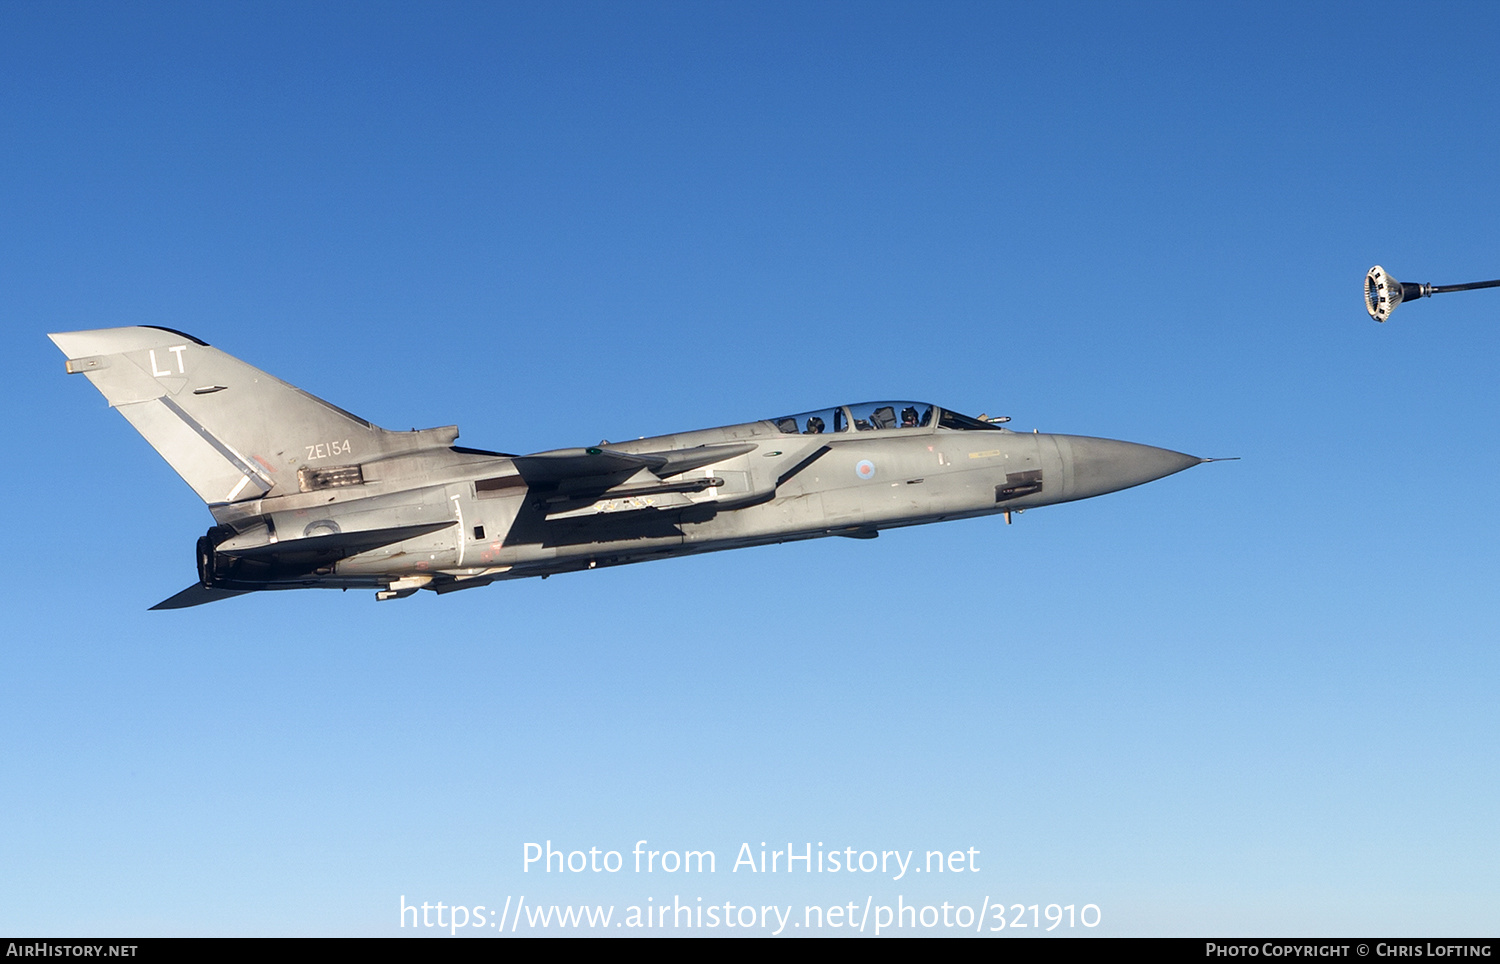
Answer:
[48,327,458,505]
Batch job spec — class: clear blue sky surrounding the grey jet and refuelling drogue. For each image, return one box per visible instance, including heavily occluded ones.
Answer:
[0,3,1500,936]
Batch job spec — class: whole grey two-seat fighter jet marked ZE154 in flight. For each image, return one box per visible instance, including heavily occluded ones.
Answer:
[50,327,1208,609]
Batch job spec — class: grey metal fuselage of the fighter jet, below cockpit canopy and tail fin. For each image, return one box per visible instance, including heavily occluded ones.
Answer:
[205,407,1199,602]
